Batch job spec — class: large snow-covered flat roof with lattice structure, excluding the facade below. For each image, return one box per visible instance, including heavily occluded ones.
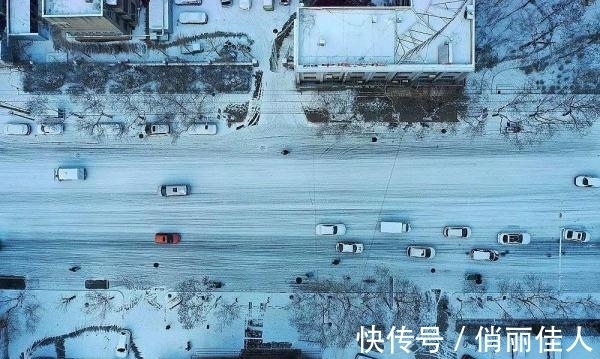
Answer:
[295,0,475,71]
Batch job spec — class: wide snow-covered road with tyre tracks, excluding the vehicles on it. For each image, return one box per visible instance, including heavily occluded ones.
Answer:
[0,122,600,292]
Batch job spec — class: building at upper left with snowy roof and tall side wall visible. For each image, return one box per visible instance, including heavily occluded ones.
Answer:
[41,0,140,41]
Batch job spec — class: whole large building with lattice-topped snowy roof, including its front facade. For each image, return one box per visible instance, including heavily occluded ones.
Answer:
[294,0,475,87]
